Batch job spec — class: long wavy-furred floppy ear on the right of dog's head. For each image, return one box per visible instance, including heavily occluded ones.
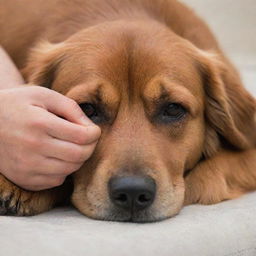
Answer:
[196,51,256,157]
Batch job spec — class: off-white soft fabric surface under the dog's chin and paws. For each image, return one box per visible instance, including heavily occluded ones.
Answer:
[0,192,256,256]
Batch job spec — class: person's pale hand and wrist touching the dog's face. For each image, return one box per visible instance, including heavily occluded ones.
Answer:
[0,47,101,191]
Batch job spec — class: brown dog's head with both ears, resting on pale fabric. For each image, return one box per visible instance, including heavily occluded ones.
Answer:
[25,21,255,222]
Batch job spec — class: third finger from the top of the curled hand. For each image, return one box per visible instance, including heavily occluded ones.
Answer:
[40,138,96,163]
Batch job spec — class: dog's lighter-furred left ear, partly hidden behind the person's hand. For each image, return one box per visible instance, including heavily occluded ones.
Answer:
[21,42,65,88]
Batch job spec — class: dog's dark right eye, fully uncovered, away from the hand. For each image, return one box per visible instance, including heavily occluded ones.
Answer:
[160,103,187,122]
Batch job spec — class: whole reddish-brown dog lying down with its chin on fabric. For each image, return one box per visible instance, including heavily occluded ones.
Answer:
[0,0,256,222]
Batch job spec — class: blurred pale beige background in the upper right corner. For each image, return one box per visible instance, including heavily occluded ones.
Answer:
[182,0,256,96]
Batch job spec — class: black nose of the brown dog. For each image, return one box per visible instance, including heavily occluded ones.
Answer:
[109,176,156,211]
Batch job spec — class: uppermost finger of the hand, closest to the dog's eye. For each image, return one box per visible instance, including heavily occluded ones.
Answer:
[30,86,93,125]
